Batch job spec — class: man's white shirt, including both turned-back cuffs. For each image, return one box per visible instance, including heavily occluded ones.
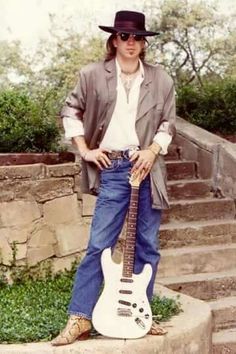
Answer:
[63,60,172,155]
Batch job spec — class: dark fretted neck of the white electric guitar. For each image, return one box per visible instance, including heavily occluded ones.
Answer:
[123,186,139,278]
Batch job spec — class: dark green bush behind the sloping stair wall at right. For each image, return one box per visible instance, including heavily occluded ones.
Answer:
[177,79,236,134]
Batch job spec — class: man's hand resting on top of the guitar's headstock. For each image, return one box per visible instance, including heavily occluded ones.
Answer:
[130,149,157,181]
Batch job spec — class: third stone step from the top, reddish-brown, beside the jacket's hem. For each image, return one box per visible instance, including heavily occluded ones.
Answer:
[167,179,212,200]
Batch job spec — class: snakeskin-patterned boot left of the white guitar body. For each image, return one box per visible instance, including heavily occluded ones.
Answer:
[51,315,92,346]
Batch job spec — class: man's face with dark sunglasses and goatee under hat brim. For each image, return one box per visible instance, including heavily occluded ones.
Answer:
[113,33,145,59]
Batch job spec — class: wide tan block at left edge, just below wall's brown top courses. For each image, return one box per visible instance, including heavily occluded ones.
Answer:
[0,201,41,227]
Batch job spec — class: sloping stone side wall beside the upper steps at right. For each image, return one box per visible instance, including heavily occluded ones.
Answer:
[175,118,236,200]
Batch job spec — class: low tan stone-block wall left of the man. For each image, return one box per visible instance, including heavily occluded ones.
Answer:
[0,163,94,270]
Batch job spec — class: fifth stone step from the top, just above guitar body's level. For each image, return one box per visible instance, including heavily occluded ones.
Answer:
[159,220,236,249]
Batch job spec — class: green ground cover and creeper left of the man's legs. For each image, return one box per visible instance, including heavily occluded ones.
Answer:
[0,258,78,343]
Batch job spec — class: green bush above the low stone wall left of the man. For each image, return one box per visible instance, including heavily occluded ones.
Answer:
[0,89,60,153]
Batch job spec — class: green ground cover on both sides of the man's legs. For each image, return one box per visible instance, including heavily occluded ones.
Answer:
[0,267,181,343]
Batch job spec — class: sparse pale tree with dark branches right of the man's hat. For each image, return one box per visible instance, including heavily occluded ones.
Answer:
[145,0,236,86]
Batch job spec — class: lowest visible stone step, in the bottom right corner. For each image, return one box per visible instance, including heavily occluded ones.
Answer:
[212,328,236,354]
